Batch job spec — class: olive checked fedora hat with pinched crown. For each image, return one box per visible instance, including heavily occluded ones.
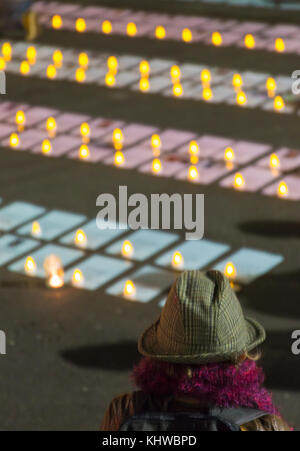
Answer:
[138,271,266,364]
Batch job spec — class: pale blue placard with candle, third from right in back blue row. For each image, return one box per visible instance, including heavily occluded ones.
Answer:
[105,230,179,261]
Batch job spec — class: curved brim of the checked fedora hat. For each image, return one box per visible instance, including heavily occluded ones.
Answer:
[138,318,266,365]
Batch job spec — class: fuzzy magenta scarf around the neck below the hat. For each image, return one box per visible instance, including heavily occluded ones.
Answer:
[132,358,278,415]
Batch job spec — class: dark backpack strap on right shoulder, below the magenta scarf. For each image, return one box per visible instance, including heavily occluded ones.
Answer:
[209,407,268,427]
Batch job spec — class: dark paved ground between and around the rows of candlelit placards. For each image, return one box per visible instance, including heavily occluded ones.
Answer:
[0,2,300,430]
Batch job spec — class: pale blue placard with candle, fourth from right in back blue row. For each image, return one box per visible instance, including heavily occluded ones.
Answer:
[59,219,128,250]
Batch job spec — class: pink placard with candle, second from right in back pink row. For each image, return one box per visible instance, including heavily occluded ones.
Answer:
[213,141,271,164]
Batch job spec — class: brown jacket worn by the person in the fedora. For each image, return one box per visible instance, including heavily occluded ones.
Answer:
[100,391,291,432]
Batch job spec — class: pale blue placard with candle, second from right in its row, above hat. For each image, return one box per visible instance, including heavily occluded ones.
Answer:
[155,239,230,271]
